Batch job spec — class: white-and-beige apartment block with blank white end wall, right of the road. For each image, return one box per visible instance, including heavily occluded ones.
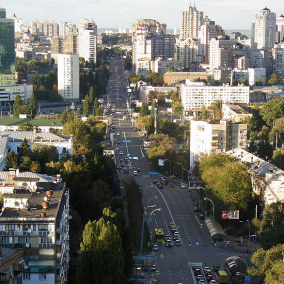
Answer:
[190,120,247,169]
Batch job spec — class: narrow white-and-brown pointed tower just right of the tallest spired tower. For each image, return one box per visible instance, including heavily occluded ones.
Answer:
[198,16,217,62]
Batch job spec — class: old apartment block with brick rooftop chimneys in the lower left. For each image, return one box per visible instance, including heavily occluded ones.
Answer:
[0,170,70,284]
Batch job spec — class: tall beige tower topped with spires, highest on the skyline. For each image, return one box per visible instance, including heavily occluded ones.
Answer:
[180,5,204,39]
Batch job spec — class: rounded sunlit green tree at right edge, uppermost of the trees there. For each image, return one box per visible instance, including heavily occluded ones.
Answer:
[260,98,284,126]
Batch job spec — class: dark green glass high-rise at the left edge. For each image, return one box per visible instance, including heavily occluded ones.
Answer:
[0,8,16,86]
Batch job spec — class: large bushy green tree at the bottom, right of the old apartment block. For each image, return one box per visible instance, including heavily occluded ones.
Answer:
[76,209,125,284]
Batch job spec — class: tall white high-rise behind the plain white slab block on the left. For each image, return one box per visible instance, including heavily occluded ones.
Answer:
[79,18,97,64]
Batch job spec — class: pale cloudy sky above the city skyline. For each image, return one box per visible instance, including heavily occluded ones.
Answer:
[0,0,284,30]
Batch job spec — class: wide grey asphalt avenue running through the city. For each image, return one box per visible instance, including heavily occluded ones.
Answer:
[106,57,251,284]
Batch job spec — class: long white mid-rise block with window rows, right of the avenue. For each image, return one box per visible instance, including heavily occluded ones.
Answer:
[181,80,249,113]
